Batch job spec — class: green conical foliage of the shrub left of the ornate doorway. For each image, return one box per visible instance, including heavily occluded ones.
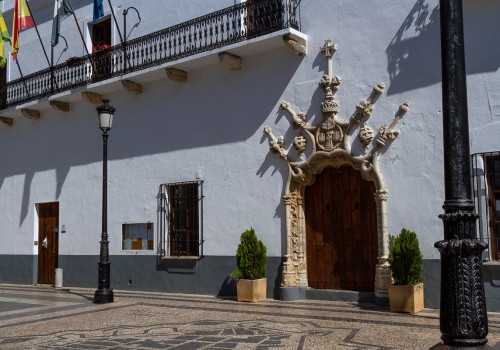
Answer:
[231,228,267,280]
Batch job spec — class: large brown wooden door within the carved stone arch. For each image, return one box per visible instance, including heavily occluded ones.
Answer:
[305,165,378,291]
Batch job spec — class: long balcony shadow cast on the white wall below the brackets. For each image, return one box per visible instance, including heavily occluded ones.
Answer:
[0,48,301,226]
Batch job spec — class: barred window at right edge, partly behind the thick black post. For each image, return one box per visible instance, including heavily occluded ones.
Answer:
[472,152,500,260]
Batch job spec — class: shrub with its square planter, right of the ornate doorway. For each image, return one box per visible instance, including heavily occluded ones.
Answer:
[387,228,424,313]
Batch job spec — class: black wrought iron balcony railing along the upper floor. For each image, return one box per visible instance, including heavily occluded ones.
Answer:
[0,0,300,109]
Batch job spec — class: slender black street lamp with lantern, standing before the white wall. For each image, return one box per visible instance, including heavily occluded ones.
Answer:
[94,100,115,304]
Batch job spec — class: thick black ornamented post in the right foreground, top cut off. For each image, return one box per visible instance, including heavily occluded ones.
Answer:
[434,0,488,347]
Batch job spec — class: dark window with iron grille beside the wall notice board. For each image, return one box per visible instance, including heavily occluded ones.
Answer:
[160,180,203,256]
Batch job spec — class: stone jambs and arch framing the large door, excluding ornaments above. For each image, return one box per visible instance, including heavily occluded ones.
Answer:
[281,157,392,299]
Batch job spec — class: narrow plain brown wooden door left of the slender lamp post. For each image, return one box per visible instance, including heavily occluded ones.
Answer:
[37,202,59,284]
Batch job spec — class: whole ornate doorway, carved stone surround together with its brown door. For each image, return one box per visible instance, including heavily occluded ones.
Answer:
[264,40,409,304]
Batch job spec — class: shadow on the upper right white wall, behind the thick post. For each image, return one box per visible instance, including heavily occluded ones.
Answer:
[386,0,500,95]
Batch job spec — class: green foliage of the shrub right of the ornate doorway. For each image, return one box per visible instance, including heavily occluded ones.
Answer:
[387,228,423,285]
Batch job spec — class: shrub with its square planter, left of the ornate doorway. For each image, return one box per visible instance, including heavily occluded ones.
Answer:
[231,228,267,303]
